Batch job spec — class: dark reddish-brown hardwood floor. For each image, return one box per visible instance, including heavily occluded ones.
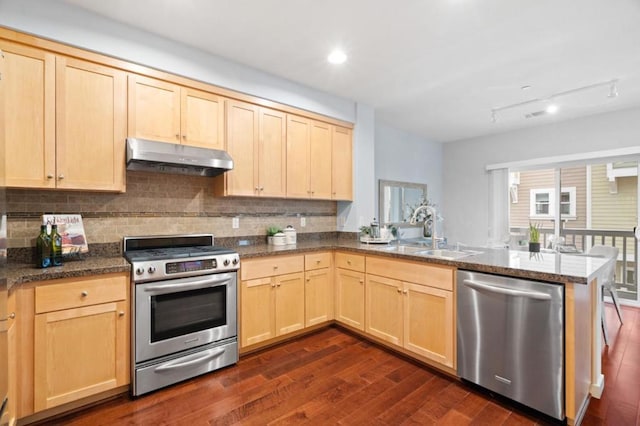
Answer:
[47,306,640,426]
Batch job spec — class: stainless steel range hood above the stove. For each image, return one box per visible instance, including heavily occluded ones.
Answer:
[127,138,233,177]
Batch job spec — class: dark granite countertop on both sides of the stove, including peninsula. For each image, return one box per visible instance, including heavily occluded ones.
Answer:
[7,238,607,288]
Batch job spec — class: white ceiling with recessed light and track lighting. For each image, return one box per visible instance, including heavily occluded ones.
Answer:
[63,0,640,142]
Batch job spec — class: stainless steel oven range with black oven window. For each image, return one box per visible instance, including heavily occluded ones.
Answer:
[124,234,240,395]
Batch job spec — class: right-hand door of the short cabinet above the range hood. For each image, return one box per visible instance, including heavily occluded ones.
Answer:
[180,87,224,149]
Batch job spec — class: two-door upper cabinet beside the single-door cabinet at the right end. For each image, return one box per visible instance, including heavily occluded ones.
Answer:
[287,115,331,200]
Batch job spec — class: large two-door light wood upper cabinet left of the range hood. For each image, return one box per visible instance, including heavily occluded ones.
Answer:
[0,41,127,191]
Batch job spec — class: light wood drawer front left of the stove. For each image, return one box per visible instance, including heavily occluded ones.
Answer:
[35,274,128,314]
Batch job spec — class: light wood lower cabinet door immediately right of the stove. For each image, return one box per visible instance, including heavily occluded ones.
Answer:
[240,278,276,348]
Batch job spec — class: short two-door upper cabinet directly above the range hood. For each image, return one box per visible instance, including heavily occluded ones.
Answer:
[129,74,224,149]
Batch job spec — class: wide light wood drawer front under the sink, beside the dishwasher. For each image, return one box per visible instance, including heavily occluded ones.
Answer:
[367,256,455,291]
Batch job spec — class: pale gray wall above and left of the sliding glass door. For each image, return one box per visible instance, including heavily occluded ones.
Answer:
[443,109,640,244]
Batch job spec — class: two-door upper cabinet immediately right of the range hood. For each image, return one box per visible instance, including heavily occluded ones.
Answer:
[216,100,286,197]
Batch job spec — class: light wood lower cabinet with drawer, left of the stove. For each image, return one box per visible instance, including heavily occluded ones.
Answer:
[33,273,129,412]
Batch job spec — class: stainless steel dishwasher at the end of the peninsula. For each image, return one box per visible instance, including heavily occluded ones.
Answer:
[457,271,565,420]
